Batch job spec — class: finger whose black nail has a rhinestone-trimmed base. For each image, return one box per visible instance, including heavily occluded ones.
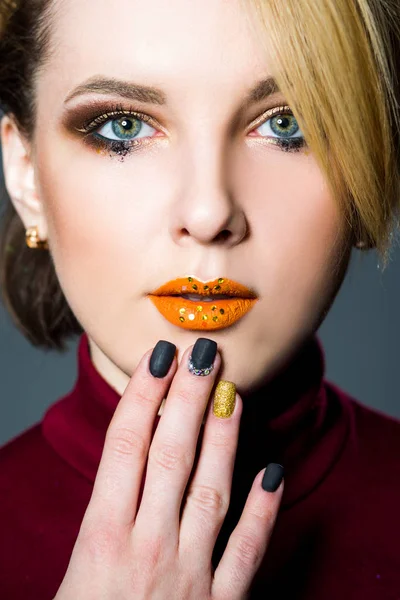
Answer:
[135,338,221,545]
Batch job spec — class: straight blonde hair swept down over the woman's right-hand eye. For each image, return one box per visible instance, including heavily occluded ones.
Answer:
[242,0,400,270]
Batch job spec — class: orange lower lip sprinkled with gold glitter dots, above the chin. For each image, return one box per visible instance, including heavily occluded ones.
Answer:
[149,294,257,331]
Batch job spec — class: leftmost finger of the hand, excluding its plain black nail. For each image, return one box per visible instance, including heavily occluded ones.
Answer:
[85,348,178,527]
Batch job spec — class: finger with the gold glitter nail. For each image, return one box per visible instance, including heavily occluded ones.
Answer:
[179,381,243,573]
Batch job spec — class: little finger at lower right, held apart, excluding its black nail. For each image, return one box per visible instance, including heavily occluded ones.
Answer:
[211,465,284,600]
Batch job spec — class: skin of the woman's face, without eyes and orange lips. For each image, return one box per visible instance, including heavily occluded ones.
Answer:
[3,0,350,395]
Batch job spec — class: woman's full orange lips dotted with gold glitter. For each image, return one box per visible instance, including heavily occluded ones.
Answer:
[149,277,258,331]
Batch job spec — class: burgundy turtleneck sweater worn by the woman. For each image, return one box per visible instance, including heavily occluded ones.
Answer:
[0,334,400,600]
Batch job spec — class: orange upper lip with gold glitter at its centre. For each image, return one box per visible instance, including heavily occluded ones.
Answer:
[150,276,258,298]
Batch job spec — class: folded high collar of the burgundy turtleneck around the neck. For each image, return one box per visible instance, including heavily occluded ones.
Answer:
[42,333,349,508]
